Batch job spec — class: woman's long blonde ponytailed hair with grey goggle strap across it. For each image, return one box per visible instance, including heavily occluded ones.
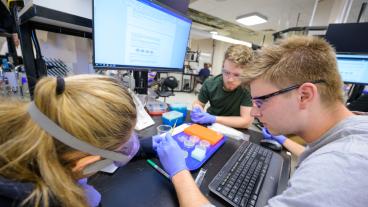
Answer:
[0,75,136,207]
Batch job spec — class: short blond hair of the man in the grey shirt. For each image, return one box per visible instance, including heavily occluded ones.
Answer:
[242,36,343,104]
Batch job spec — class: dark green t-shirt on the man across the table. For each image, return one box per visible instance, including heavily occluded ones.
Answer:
[198,75,252,116]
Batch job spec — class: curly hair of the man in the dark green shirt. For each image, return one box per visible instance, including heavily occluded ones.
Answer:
[224,45,253,69]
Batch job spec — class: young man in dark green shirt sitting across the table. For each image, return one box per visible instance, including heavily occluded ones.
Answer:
[191,45,253,128]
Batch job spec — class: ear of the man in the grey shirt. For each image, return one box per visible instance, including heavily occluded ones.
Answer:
[298,83,318,109]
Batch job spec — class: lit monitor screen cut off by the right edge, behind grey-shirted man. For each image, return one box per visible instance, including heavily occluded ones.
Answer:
[336,54,368,85]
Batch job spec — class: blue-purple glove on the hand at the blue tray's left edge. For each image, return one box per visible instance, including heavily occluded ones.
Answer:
[157,133,187,177]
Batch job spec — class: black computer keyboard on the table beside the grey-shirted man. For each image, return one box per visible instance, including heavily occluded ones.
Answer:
[208,142,283,207]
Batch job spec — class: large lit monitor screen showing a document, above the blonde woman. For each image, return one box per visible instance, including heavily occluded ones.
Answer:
[93,0,192,71]
